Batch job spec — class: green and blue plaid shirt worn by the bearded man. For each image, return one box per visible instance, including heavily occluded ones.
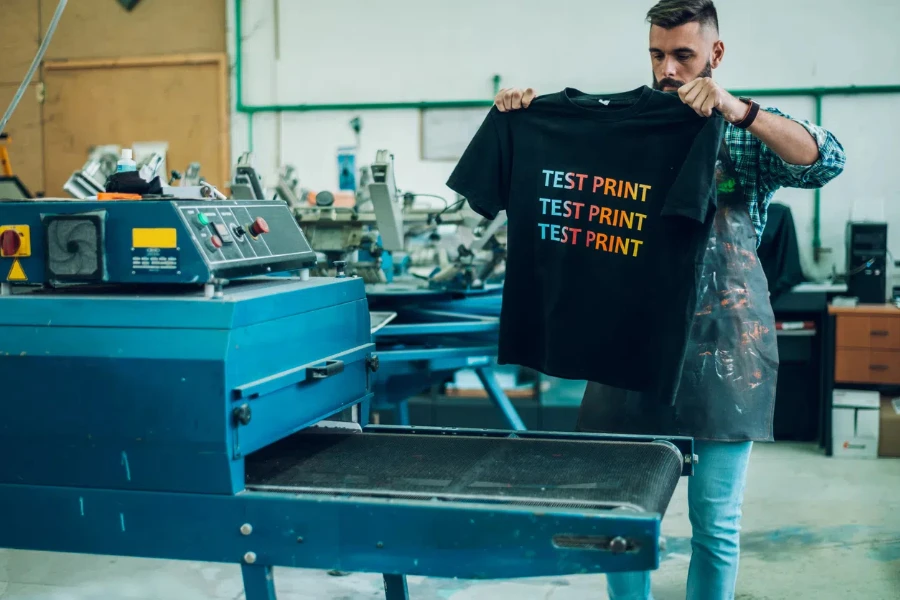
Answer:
[725,108,846,246]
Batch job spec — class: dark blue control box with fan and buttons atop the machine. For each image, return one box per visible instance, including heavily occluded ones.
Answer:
[0,199,316,284]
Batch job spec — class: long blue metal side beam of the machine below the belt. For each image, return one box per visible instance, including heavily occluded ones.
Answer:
[0,484,660,579]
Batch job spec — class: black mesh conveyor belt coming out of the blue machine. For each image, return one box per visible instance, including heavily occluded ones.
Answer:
[246,433,682,515]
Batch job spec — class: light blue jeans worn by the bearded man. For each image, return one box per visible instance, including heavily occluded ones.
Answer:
[606,440,753,600]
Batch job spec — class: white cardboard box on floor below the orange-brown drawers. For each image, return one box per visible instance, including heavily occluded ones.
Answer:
[831,390,881,458]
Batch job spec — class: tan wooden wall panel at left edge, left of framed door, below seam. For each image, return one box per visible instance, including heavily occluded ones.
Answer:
[0,84,44,194]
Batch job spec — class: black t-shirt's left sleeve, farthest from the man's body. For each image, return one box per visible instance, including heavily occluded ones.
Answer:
[447,107,512,219]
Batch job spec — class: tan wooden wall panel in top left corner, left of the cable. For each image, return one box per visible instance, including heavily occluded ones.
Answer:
[0,0,40,85]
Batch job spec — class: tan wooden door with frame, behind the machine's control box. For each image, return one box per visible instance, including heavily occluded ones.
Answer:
[44,54,230,195]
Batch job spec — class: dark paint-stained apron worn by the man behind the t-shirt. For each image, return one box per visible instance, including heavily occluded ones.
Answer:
[577,145,778,441]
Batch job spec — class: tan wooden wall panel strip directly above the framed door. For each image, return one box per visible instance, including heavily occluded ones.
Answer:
[42,0,227,59]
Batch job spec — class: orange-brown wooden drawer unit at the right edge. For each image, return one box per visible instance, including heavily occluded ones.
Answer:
[831,305,900,385]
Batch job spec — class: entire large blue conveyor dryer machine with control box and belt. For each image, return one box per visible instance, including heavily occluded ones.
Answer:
[0,199,694,600]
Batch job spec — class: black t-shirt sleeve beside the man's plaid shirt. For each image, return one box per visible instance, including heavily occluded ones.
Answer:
[662,115,725,223]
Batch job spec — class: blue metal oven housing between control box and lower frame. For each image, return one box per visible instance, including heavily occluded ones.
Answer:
[0,278,374,494]
